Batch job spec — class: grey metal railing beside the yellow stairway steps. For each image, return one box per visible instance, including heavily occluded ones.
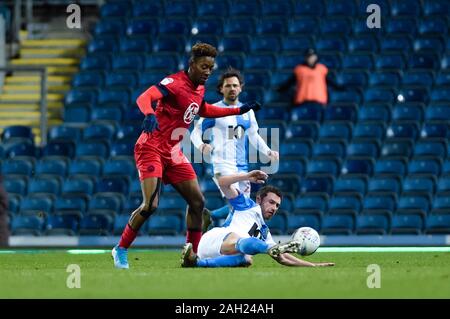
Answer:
[0,66,48,146]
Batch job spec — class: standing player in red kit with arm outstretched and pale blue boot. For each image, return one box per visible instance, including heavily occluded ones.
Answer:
[112,43,260,269]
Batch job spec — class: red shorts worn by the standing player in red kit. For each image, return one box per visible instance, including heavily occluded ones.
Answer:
[134,143,197,184]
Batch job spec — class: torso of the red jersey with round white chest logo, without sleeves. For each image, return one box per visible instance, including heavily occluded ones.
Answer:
[138,71,205,151]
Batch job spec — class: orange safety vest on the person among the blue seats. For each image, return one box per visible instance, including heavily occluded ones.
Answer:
[294,63,328,104]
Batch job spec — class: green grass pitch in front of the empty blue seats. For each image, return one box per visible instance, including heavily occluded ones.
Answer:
[0,249,450,299]
